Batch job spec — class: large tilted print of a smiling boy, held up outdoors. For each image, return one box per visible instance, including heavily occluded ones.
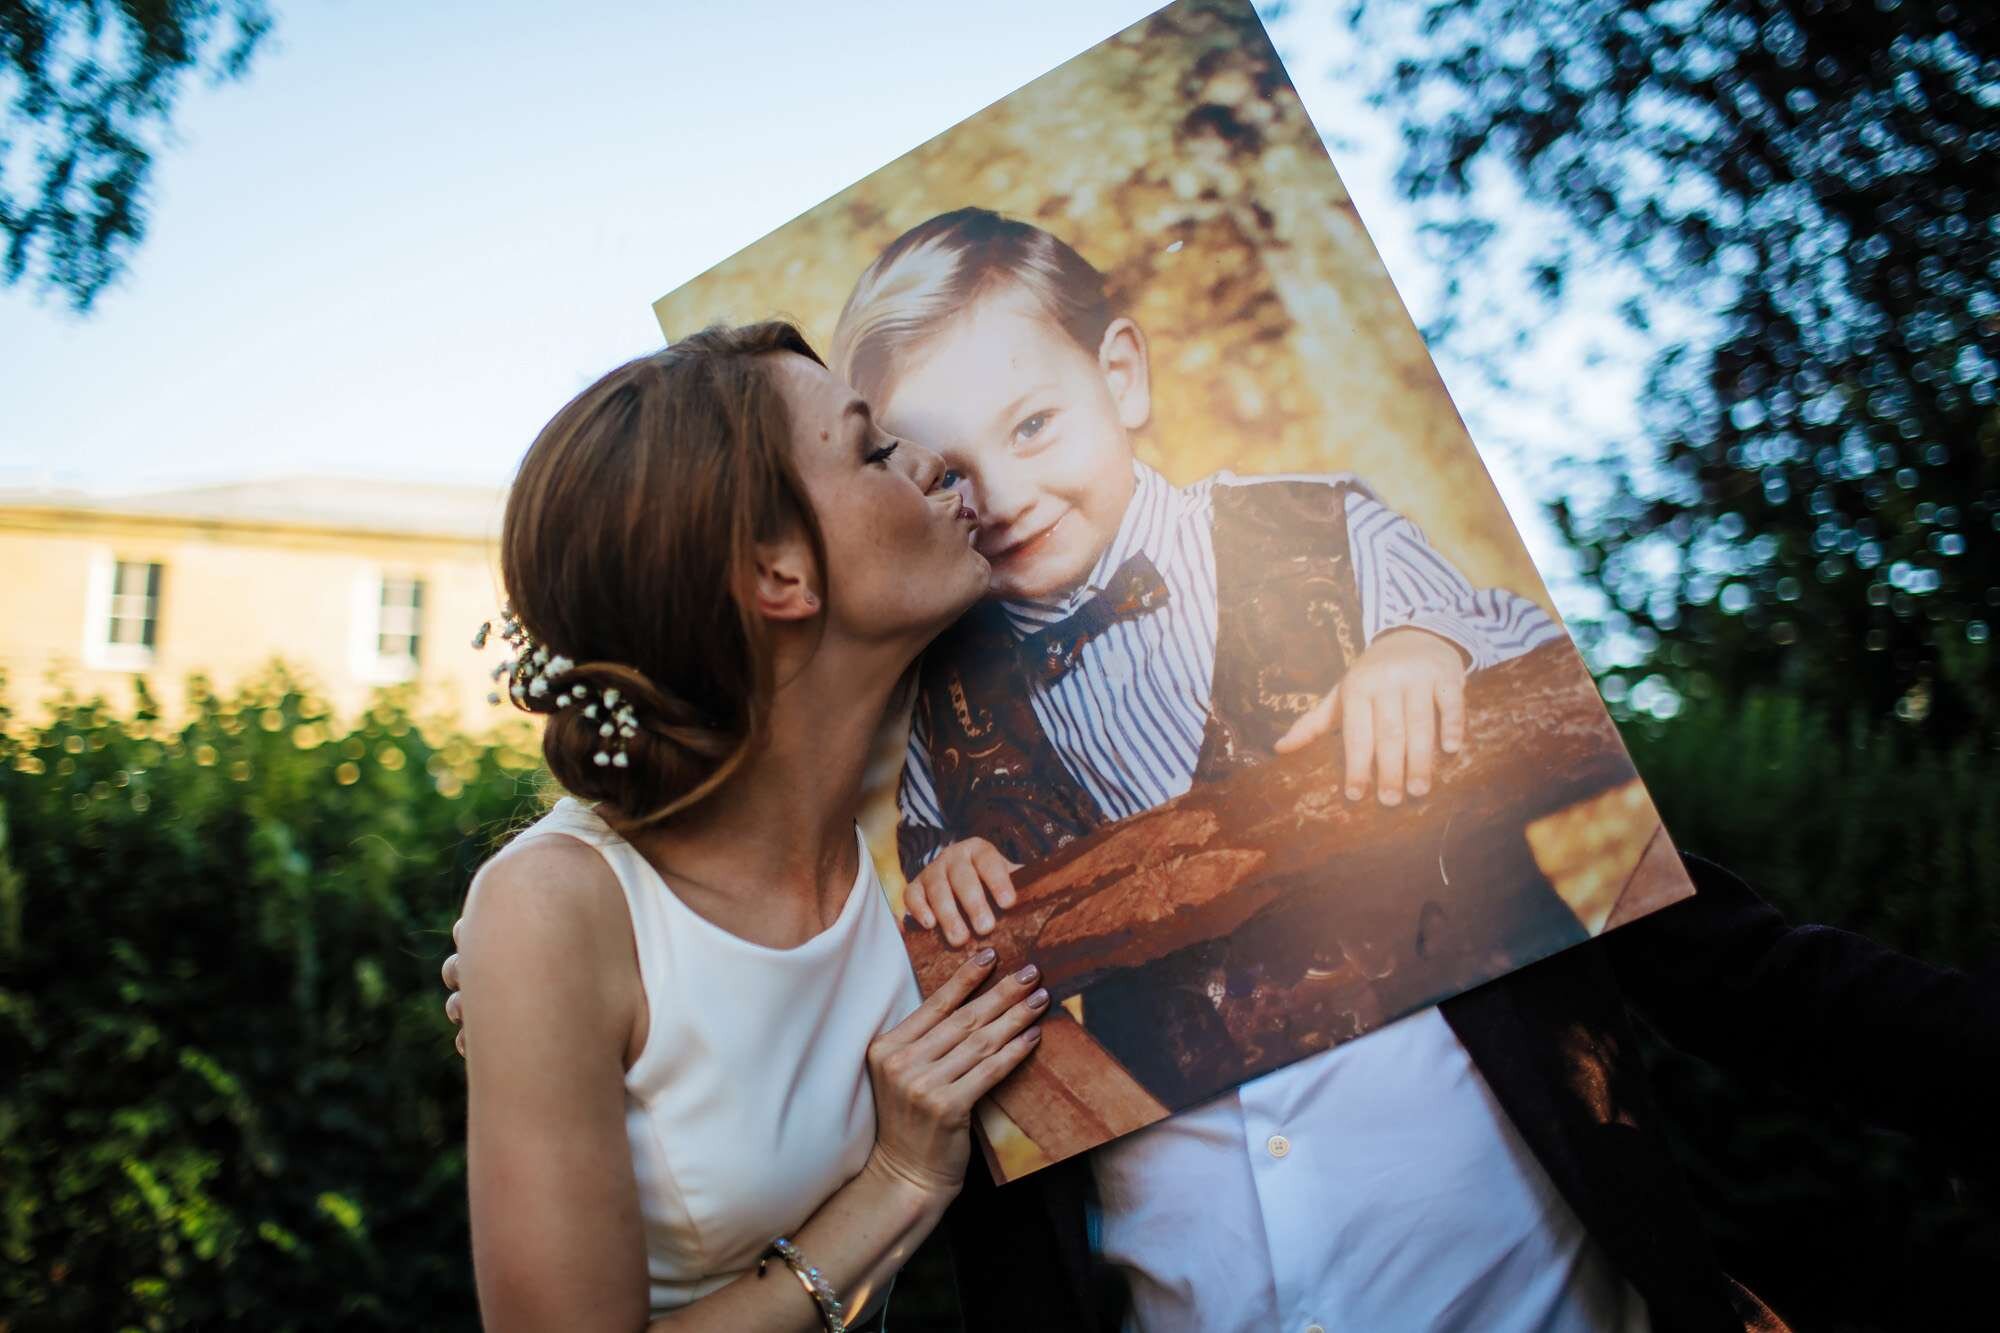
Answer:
[656,0,1692,1179]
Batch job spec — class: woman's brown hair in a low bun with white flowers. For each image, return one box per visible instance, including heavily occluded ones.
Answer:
[500,322,826,829]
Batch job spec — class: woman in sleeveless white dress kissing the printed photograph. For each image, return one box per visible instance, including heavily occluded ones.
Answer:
[458,324,1048,1329]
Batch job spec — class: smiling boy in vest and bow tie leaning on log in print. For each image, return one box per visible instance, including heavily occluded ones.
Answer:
[830,208,1586,1109]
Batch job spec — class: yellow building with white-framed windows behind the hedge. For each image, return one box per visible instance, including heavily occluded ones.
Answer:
[0,478,506,733]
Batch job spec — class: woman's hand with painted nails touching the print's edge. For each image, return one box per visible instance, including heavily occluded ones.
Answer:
[868,949,1048,1199]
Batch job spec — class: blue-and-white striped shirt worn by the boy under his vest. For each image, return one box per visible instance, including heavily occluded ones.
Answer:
[898,462,1562,841]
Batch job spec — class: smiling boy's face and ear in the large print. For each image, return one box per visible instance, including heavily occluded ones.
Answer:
[878,284,1152,600]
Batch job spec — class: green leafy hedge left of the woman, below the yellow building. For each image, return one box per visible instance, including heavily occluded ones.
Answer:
[0,673,538,1333]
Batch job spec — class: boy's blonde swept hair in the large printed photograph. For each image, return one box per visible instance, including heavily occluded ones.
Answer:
[830,208,1112,398]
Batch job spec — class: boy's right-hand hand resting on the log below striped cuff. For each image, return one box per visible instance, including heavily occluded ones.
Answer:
[1278,626,1466,805]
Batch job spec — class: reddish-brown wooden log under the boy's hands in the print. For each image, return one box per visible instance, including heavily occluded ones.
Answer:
[910,642,1636,997]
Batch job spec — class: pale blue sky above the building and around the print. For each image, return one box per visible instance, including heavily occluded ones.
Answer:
[0,0,1642,608]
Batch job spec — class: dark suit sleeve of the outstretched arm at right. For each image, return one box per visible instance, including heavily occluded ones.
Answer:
[1602,857,2000,1179]
